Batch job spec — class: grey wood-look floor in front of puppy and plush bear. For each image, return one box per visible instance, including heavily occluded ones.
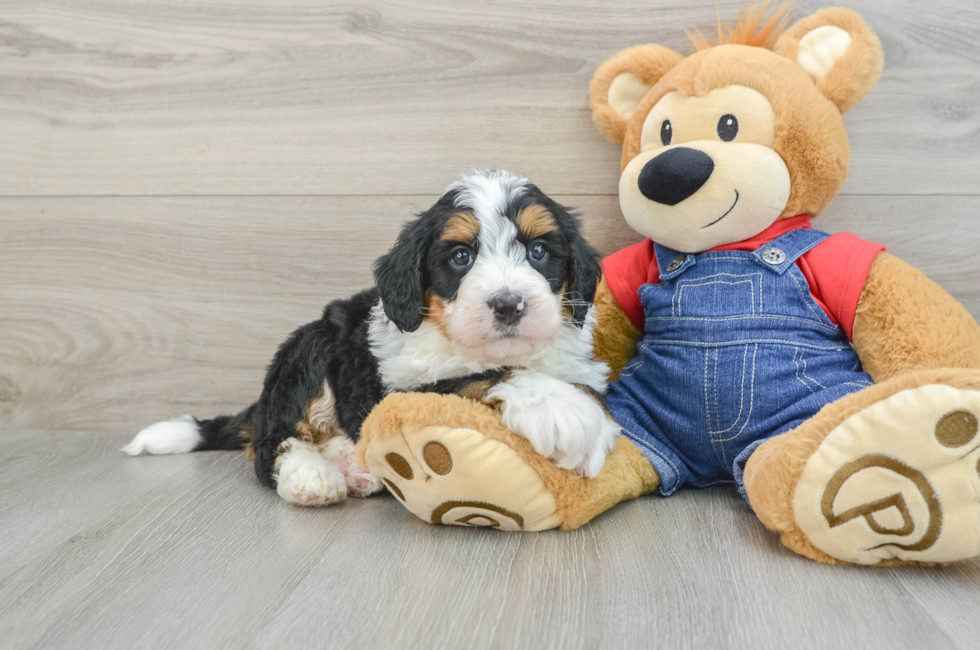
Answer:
[0,431,980,650]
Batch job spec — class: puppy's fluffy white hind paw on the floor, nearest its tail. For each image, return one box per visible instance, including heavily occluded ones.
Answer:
[276,438,347,506]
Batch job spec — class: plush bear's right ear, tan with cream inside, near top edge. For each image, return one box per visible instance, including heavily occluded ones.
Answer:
[774,7,884,113]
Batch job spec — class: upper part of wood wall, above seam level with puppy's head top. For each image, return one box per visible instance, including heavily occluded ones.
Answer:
[0,0,980,196]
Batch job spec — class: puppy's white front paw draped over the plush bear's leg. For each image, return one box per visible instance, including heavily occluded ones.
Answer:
[489,370,620,478]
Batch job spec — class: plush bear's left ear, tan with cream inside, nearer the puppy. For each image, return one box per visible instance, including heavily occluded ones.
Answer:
[589,45,684,144]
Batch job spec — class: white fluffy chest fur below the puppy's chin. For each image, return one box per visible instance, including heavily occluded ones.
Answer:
[368,301,609,393]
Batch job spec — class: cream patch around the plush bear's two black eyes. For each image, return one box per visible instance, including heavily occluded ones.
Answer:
[640,86,776,151]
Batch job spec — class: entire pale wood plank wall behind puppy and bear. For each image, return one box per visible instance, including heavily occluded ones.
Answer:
[0,0,980,431]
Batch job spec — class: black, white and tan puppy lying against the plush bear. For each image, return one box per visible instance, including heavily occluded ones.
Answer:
[124,171,619,505]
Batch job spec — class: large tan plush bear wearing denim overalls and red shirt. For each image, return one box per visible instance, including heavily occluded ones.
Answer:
[359,3,980,565]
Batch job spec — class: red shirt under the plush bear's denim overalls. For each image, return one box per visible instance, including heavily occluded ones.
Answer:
[602,215,885,340]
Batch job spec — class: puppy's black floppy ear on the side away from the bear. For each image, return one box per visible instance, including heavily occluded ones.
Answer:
[374,215,428,332]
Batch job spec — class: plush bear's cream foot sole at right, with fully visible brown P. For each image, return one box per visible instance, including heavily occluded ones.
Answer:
[793,384,980,564]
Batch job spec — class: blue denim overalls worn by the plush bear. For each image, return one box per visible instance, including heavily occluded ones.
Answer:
[608,228,872,496]
